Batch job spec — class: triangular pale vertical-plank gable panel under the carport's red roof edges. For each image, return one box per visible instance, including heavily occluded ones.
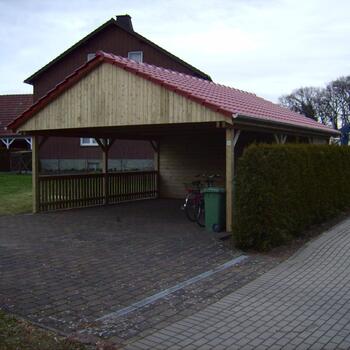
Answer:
[19,63,227,131]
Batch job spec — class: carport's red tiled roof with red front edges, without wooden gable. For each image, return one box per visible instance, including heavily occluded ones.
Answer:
[9,51,338,135]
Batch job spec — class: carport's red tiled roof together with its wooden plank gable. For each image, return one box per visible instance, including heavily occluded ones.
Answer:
[9,51,337,137]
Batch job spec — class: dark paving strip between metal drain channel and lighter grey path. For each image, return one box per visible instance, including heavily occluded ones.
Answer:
[80,252,279,344]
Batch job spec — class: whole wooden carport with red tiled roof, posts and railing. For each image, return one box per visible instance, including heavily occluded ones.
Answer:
[9,52,337,231]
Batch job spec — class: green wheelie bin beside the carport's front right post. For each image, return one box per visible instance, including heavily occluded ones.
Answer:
[202,187,226,232]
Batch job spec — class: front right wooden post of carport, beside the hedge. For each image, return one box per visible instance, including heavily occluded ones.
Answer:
[226,128,234,232]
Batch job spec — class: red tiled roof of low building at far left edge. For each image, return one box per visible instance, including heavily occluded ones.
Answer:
[0,94,33,136]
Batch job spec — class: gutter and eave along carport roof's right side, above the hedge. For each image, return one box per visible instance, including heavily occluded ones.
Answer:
[232,113,340,137]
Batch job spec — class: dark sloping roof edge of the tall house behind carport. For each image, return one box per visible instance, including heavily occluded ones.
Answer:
[24,18,211,84]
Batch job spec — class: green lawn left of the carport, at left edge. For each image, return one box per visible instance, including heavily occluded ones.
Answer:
[0,173,32,215]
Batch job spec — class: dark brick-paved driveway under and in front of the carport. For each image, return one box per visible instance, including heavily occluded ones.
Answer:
[0,200,250,343]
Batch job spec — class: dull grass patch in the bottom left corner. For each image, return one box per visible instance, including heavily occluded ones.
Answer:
[0,310,86,350]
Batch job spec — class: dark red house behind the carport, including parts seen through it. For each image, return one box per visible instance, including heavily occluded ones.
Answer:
[0,15,211,170]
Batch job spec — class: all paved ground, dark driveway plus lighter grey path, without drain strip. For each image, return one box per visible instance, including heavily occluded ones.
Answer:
[4,201,350,349]
